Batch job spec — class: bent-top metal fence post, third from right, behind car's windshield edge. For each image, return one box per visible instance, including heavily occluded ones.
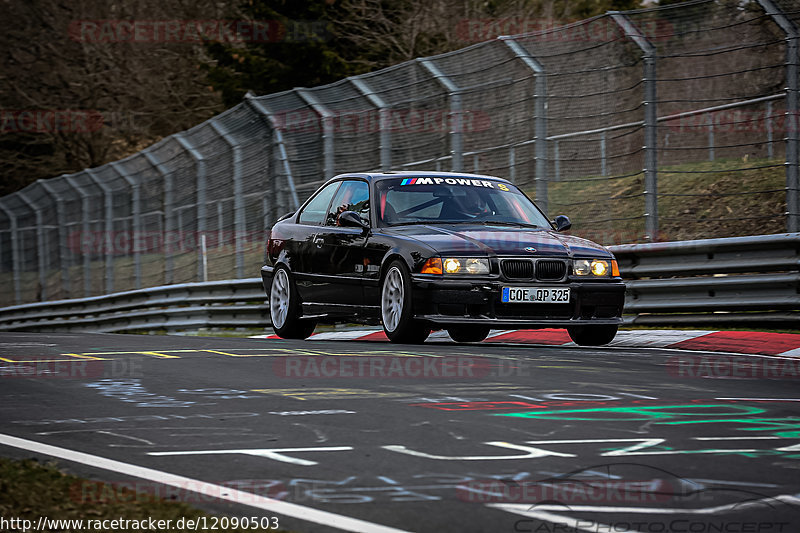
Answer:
[498,36,548,213]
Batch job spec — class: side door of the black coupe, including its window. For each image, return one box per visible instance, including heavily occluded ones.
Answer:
[311,179,370,311]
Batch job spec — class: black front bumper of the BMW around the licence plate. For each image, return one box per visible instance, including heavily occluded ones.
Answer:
[412,275,625,329]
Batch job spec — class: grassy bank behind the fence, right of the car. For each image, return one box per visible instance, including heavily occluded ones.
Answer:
[548,158,786,244]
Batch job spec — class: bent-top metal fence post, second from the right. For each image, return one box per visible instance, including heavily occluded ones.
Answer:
[608,11,658,241]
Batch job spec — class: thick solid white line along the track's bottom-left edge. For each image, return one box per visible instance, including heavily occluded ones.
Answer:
[0,433,407,533]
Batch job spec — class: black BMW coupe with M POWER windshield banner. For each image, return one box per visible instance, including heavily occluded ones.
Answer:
[261,172,625,346]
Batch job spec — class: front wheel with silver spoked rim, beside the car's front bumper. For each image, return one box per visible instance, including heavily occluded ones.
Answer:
[381,261,431,344]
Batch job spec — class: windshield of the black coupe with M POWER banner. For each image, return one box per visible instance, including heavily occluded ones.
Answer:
[376,176,550,228]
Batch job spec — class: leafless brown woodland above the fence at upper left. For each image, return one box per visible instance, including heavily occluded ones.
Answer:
[0,0,231,194]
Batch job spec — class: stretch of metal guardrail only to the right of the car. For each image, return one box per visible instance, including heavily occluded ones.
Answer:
[609,233,800,327]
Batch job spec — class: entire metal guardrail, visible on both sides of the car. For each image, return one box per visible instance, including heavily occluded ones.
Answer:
[0,233,800,332]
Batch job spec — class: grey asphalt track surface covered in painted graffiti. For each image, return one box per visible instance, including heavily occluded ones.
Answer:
[0,333,800,533]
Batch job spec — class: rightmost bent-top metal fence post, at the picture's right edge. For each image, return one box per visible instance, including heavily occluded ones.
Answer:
[758,0,800,233]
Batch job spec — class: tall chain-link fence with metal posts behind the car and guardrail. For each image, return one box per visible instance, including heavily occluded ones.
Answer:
[0,0,800,306]
